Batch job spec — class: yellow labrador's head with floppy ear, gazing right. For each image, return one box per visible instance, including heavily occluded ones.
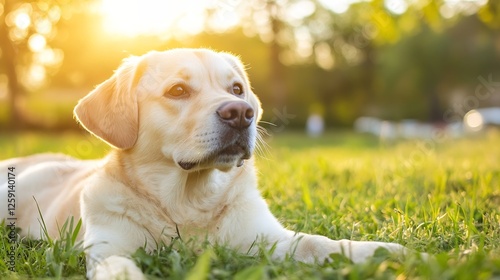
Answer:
[74,49,262,170]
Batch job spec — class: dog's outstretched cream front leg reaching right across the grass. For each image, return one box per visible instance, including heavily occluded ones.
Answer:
[225,197,408,263]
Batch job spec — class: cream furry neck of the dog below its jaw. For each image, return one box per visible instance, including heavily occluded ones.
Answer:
[105,150,249,228]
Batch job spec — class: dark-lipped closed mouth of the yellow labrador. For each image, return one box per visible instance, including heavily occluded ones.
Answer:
[177,142,251,170]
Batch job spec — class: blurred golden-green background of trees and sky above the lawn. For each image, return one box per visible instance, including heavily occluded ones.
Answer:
[0,0,500,137]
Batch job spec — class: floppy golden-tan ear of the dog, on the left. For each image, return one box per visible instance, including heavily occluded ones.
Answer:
[73,57,146,149]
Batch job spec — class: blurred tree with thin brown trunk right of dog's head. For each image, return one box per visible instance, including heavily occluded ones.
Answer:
[231,0,316,111]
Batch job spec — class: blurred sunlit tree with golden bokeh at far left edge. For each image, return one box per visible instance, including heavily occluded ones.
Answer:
[0,0,88,128]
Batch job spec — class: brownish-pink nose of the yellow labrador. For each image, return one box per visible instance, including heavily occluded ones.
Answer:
[217,101,254,129]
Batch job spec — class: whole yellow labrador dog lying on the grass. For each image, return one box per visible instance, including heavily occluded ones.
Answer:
[0,49,414,279]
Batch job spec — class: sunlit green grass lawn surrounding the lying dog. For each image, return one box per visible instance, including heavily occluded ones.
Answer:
[0,131,500,280]
